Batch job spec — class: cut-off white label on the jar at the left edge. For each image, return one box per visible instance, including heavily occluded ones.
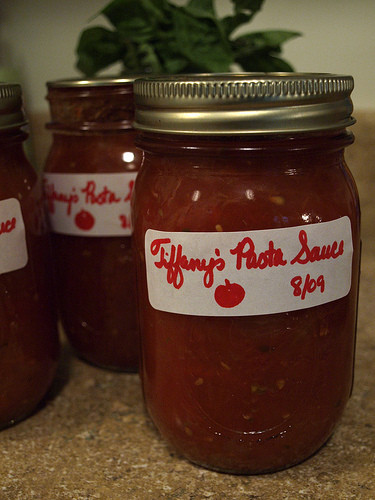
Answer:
[0,198,28,274]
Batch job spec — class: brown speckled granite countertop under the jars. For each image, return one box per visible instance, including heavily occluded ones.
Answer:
[0,113,375,500]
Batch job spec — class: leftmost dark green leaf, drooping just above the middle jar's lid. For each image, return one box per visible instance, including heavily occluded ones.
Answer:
[76,26,121,76]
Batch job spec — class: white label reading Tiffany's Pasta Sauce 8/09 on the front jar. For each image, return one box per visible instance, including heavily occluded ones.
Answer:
[145,217,353,316]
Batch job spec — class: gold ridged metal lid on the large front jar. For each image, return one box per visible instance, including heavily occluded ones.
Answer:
[134,73,355,135]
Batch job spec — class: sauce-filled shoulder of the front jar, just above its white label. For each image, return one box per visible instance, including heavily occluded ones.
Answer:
[134,155,358,231]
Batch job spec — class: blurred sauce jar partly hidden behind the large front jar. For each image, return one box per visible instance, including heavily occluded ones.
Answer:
[44,78,141,371]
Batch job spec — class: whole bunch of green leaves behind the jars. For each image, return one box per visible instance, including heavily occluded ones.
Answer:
[77,0,300,77]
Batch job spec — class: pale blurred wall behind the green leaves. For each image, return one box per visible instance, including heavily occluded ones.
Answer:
[0,0,375,113]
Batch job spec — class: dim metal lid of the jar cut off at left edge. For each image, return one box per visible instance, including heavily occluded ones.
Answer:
[0,83,27,130]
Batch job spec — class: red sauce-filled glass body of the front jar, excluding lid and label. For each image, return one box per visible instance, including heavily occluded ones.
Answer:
[133,131,360,473]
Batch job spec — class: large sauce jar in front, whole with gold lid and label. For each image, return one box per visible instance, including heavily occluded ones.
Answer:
[132,74,360,474]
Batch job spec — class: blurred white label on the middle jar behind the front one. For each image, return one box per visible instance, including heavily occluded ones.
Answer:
[44,172,137,236]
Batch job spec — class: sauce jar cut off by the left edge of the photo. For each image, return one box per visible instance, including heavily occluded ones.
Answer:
[0,83,59,428]
